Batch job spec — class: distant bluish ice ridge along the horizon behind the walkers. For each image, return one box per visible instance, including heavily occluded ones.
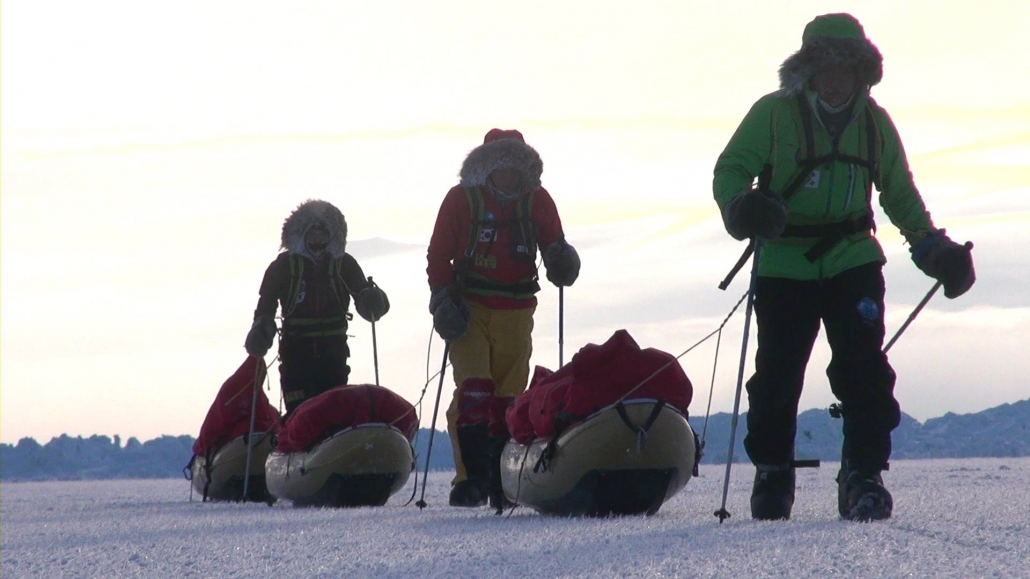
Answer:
[0,399,1030,480]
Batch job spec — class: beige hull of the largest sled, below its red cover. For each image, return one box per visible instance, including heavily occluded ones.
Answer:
[501,400,697,516]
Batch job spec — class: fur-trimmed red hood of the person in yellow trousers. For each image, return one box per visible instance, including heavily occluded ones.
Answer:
[459,129,544,195]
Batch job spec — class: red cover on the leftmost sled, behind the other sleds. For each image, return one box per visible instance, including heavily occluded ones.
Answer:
[194,356,279,456]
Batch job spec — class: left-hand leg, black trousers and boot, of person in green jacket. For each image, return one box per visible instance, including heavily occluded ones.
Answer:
[744,271,819,519]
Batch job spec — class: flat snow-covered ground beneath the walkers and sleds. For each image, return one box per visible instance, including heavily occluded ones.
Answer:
[0,458,1030,579]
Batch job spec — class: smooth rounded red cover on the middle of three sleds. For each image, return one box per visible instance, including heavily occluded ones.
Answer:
[275,384,418,452]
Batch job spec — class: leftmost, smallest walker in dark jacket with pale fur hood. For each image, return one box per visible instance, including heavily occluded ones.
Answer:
[244,200,389,416]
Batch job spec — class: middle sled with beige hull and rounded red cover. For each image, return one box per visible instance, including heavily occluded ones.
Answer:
[265,384,418,507]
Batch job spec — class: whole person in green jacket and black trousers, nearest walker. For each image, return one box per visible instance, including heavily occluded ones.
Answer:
[713,13,975,520]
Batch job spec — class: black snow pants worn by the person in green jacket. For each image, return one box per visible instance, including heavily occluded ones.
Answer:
[744,263,901,472]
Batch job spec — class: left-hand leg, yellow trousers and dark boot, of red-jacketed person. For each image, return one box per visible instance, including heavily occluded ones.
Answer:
[447,302,493,507]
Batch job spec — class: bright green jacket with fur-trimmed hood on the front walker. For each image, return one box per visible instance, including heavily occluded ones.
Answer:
[713,14,933,280]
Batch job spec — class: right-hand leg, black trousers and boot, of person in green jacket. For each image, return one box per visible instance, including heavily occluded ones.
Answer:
[823,264,901,519]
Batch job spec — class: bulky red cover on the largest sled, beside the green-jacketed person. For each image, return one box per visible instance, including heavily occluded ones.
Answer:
[505,330,693,444]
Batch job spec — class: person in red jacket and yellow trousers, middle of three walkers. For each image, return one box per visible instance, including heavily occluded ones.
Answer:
[426,129,580,508]
